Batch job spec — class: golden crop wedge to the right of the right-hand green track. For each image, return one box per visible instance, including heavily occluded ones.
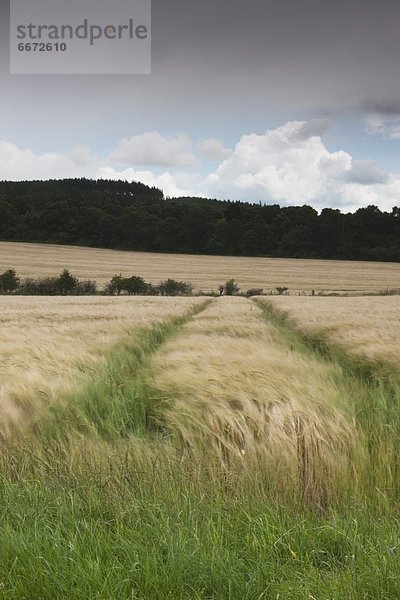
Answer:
[271,296,400,367]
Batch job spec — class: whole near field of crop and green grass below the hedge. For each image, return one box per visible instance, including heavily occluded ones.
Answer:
[0,296,400,600]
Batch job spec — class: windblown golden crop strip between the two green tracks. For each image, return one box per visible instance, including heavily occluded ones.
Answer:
[152,297,357,502]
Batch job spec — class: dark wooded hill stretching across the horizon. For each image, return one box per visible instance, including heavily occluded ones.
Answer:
[0,179,400,262]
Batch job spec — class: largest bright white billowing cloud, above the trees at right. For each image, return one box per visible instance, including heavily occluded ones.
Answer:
[204,120,400,210]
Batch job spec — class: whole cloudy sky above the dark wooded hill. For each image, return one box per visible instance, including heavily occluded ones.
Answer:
[0,0,400,211]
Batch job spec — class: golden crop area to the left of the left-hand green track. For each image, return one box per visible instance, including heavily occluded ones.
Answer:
[0,296,199,437]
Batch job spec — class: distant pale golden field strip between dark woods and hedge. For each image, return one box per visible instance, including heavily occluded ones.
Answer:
[0,242,400,293]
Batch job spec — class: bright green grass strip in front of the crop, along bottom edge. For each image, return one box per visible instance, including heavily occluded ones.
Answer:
[0,470,400,600]
